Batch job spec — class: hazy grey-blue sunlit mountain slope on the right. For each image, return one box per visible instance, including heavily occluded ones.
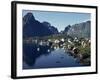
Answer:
[64,21,91,38]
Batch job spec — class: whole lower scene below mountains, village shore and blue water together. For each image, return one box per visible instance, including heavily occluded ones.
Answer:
[23,35,91,69]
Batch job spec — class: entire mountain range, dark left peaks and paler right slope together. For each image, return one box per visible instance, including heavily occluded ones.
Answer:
[23,13,91,38]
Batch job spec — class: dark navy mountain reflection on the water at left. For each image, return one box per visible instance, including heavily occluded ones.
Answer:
[23,44,51,66]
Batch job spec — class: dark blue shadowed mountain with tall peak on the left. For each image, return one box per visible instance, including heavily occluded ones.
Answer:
[23,13,58,38]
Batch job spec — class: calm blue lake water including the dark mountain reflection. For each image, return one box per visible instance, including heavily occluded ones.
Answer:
[23,44,81,69]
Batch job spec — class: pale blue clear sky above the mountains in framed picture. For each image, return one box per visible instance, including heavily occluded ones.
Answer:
[22,10,91,31]
